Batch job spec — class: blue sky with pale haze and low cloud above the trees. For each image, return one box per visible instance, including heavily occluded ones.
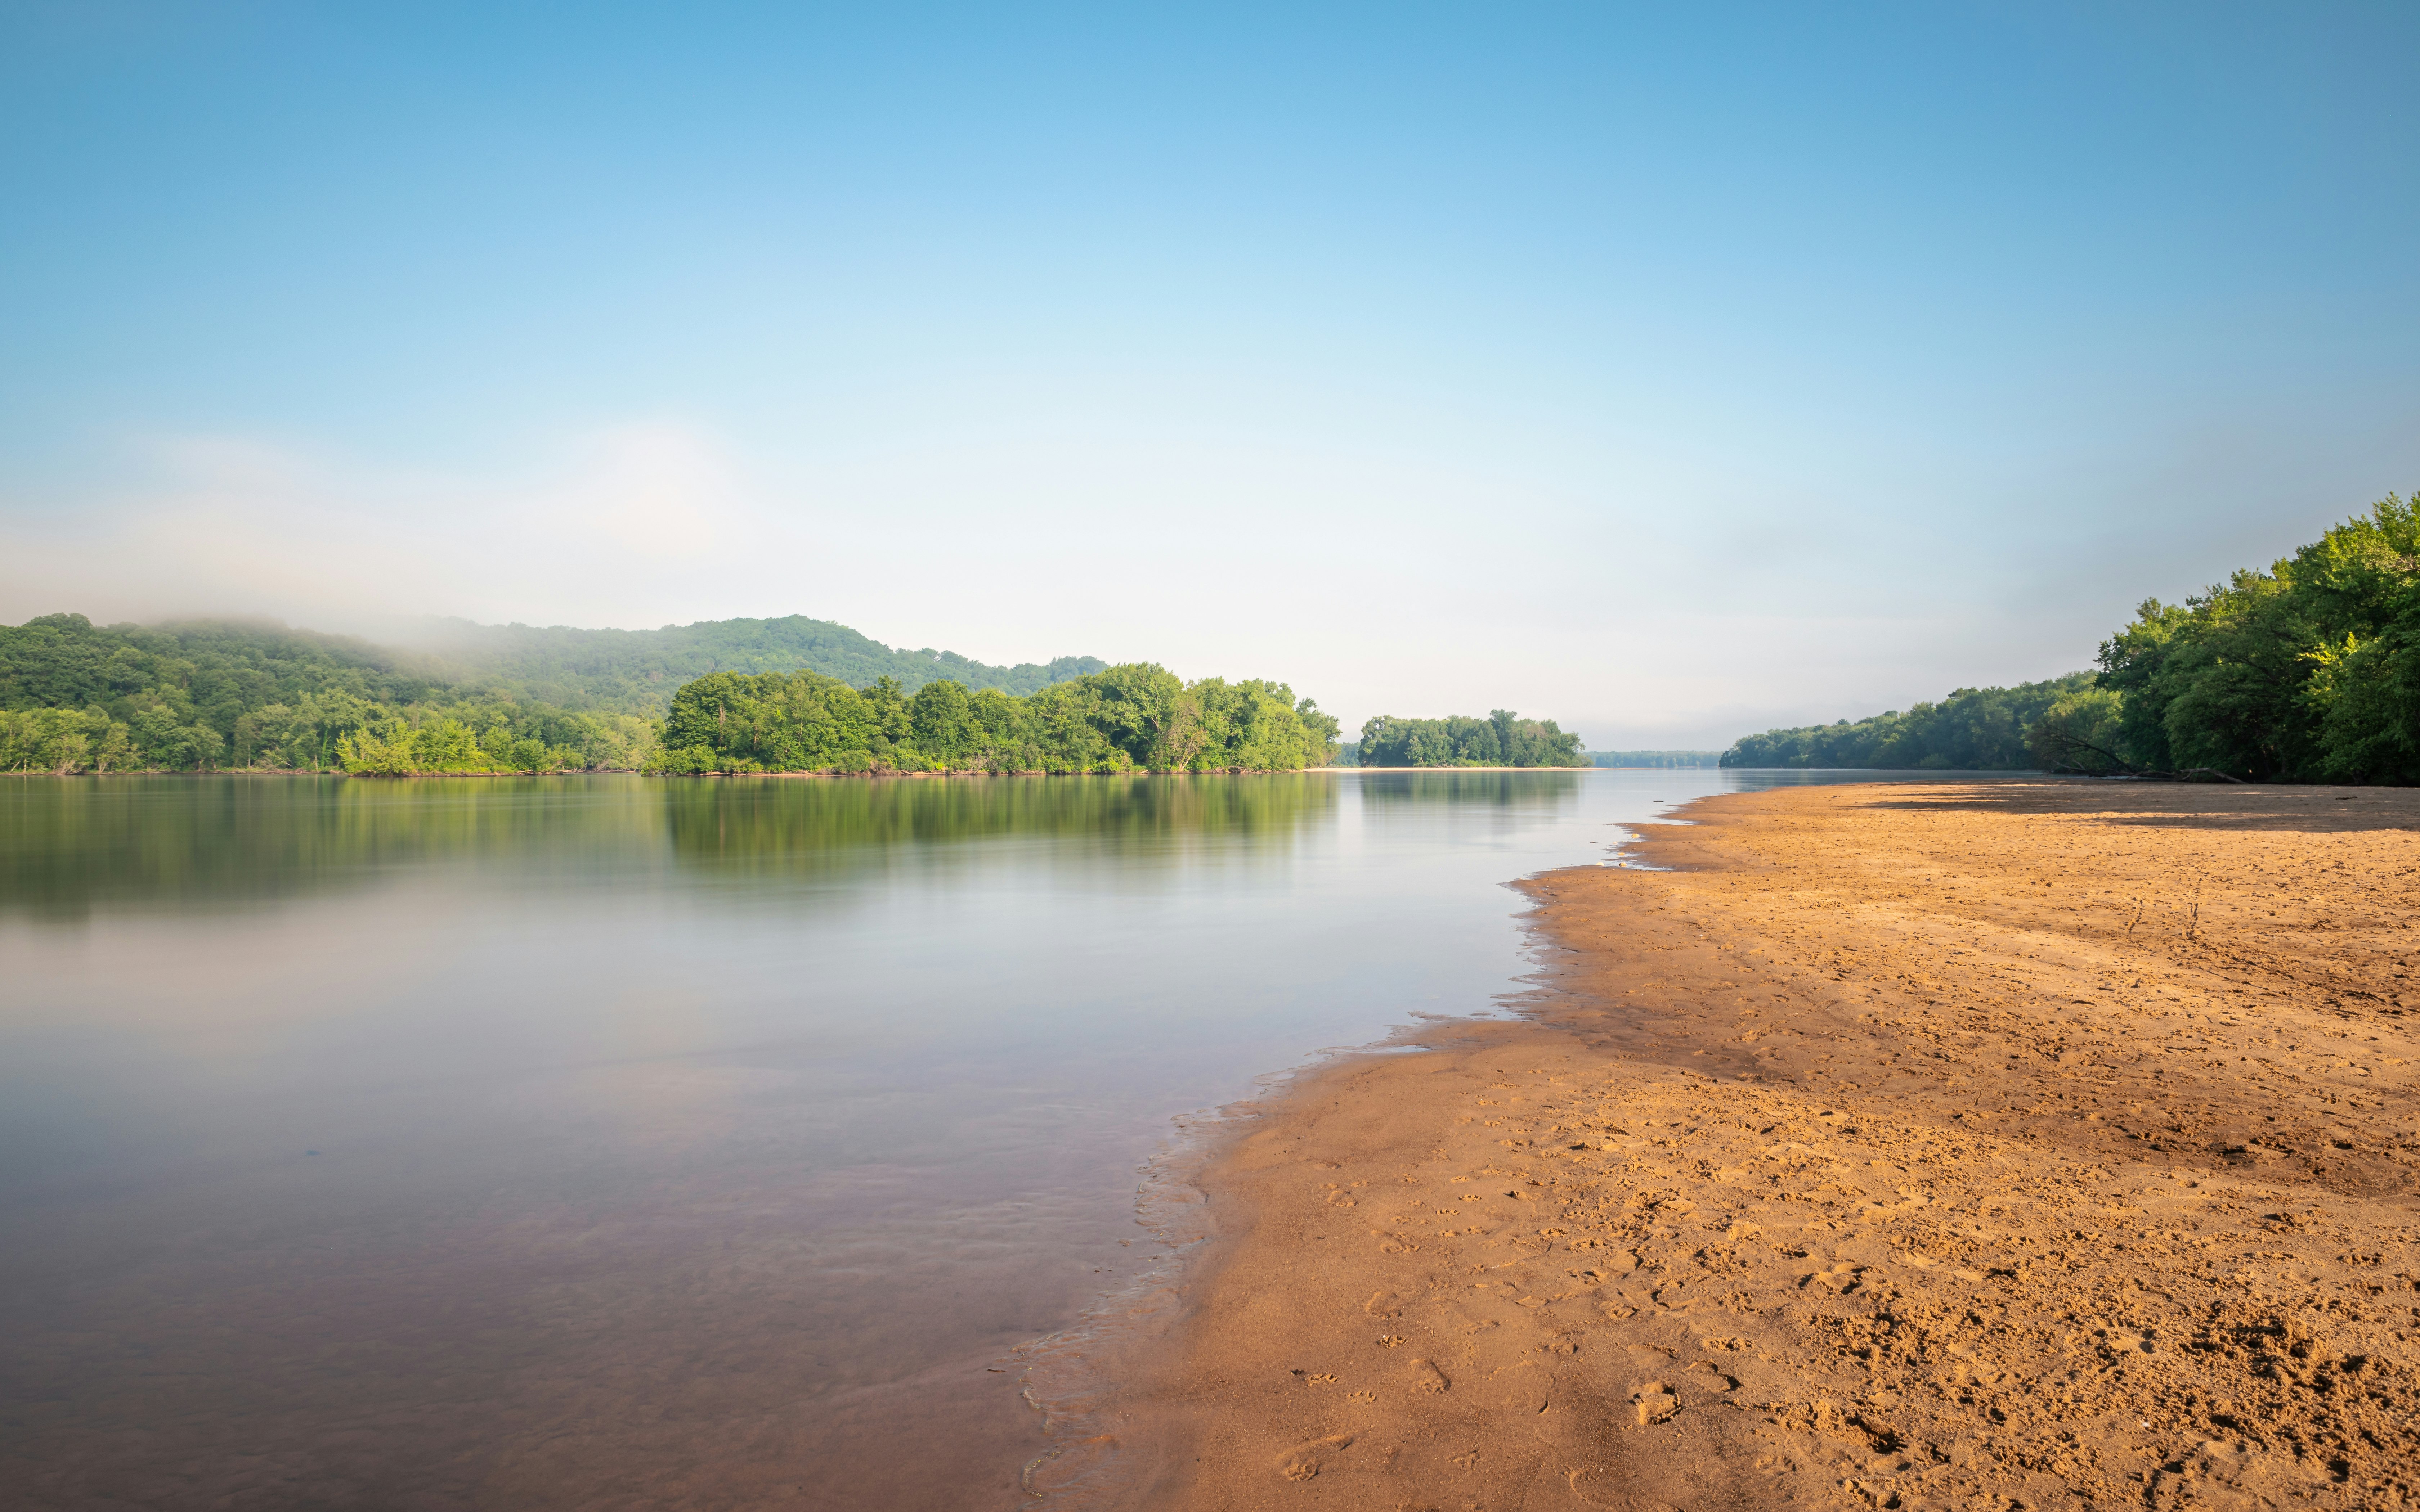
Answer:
[0,3,2420,747]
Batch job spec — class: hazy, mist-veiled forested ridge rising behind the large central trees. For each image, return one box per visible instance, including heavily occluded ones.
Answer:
[409,615,1108,716]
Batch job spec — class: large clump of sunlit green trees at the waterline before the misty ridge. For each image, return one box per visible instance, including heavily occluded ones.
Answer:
[649,663,1336,772]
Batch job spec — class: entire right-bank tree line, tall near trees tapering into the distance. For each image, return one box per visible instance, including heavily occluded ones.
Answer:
[1723,494,2420,784]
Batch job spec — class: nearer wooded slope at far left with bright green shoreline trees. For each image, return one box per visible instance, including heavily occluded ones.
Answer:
[0,615,653,772]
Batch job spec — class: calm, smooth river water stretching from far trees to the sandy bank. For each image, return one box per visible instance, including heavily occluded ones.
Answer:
[0,772,1965,1509]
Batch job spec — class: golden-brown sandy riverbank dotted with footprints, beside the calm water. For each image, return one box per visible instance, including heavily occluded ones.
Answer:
[1116,782,2420,1512]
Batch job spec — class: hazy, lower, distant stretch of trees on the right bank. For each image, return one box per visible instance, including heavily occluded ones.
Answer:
[1723,672,2093,772]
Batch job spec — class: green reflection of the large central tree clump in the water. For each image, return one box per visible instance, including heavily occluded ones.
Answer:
[663,772,1336,871]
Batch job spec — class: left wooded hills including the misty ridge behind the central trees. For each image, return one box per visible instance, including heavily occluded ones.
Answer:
[0,615,1108,774]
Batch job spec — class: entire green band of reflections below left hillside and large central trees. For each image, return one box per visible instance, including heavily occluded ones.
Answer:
[0,774,1365,919]
